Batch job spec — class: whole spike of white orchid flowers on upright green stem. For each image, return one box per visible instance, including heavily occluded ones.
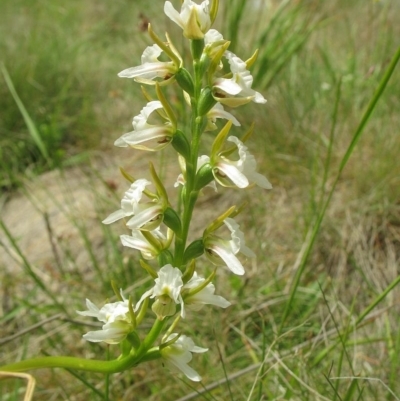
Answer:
[78,0,271,381]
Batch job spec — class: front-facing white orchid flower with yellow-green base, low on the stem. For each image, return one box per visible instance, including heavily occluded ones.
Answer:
[135,264,185,320]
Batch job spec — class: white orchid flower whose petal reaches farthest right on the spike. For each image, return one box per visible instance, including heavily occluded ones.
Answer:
[211,136,272,189]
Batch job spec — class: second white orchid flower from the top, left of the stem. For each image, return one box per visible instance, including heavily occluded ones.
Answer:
[114,100,176,152]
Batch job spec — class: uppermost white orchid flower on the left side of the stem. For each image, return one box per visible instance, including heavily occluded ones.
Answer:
[118,44,178,85]
